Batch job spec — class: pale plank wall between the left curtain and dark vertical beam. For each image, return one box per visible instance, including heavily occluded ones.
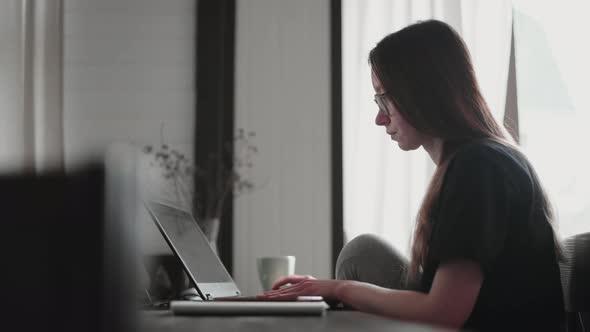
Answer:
[64,0,196,252]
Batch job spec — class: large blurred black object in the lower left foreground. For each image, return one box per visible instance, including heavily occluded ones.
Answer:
[0,146,136,331]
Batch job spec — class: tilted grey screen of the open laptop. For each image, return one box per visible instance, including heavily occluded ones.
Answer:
[149,202,233,284]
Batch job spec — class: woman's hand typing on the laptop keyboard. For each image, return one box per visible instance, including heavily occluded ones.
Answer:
[258,276,344,301]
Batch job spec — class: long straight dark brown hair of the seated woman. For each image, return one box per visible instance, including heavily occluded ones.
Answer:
[369,20,553,277]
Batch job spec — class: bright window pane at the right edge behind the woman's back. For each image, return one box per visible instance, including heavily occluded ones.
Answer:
[514,0,590,237]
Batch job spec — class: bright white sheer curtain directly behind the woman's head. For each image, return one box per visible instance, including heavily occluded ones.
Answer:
[342,0,511,254]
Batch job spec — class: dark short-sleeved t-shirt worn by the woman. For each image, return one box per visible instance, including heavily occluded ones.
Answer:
[421,140,564,331]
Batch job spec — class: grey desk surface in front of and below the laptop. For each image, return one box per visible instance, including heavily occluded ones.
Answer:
[139,311,445,332]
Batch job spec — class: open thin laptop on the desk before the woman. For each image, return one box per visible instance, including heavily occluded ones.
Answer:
[145,200,328,315]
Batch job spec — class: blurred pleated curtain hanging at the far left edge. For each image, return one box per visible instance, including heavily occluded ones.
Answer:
[0,0,63,172]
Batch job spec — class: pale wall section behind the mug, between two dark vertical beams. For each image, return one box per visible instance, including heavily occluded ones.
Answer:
[234,0,332,294]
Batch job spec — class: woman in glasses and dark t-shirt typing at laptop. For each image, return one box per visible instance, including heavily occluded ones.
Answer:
[261,20,564,331]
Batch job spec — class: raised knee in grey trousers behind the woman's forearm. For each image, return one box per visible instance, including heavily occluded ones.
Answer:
[336,234,416,289]
